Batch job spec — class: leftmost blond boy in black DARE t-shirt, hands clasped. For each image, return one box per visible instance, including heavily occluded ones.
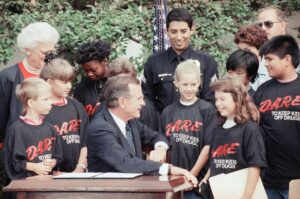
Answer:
[4,77,63,180]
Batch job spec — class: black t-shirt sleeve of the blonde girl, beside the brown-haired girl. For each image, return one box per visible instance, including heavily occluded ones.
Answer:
[202,105,217,146]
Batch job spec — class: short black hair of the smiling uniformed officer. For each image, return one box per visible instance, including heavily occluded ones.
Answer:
[166,8,193,29]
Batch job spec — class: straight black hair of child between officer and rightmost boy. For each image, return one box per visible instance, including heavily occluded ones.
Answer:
[226,49,259,83]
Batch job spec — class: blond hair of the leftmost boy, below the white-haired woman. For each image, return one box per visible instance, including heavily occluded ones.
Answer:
[16,77,51,108]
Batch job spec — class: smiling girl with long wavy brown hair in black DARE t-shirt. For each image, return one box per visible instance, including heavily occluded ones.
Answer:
[200,76,266,198]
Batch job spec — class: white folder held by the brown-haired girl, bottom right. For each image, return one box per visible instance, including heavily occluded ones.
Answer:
[209,168,268,199]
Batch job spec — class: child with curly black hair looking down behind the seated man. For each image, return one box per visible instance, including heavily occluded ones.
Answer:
[74,40,111,118]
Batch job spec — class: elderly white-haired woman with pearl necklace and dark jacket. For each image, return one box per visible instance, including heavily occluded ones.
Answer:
[0,22,59,149]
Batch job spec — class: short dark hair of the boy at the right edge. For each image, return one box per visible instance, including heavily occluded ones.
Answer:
[259,35,300,68]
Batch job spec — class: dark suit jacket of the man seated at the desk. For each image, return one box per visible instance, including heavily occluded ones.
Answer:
[86,106,167,175]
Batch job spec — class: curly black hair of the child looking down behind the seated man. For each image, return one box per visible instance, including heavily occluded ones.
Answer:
[75,40,111,64]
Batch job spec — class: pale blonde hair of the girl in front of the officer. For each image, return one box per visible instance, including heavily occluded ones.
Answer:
[174,59,202,85]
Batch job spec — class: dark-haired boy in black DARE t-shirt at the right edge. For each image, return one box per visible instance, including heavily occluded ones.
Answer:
[254,35,300,199]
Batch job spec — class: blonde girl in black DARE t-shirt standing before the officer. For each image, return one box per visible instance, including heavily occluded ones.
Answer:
[160,60,217,198]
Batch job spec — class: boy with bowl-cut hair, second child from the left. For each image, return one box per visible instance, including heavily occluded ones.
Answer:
[41,58,88,172]
